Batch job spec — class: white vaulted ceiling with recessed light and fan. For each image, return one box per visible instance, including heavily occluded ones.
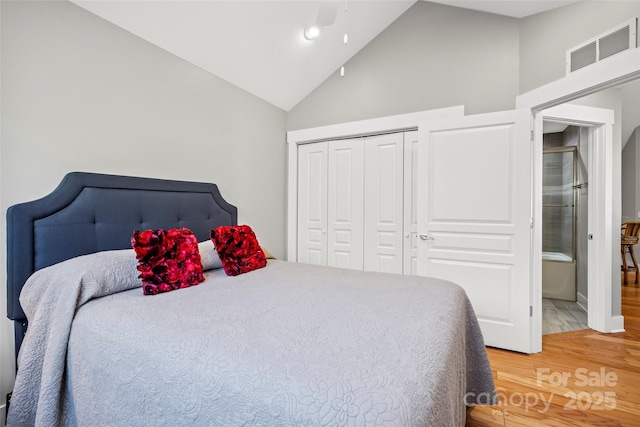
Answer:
[71,0,575,111]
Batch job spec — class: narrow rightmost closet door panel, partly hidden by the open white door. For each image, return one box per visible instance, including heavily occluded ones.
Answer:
[402,131,418,276]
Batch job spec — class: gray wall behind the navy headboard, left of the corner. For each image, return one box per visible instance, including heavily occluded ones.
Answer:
[0,0,286,418]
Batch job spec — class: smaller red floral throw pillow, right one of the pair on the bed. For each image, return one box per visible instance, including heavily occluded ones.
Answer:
[211,225,267,276]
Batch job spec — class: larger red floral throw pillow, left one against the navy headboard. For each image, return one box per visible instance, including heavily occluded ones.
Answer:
[131,228,204,295]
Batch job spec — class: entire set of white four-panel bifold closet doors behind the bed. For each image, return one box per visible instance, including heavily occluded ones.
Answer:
[297,132,417,274]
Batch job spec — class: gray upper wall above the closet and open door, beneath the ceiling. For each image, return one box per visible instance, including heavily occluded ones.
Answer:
[287,1,640,130]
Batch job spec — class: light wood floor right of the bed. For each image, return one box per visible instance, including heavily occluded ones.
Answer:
[466,275,640,427]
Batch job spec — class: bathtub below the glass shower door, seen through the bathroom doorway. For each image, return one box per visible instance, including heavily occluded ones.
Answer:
[542,252,576,301]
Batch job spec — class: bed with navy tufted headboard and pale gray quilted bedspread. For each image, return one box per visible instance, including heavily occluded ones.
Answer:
[7,172,496,426]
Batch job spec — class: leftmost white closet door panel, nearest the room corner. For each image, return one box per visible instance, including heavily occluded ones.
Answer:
[298,142,327,265]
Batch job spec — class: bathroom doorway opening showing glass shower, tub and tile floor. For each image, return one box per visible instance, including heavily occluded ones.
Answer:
[542,122,588,334]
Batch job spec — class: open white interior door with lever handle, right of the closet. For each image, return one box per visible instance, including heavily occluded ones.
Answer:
[418,110,532,353]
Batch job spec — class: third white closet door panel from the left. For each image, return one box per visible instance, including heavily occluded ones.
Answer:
[364,133,404,274]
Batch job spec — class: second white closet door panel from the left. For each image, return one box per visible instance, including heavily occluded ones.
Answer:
[327,139,364,270]
